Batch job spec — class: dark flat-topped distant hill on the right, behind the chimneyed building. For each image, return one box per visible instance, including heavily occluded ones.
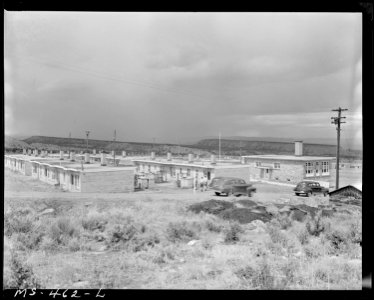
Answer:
[191,139,362,159]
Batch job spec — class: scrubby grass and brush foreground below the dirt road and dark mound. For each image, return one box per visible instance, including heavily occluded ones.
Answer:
[4,191,362,289]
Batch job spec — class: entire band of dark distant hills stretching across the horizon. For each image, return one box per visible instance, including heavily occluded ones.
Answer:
[5,136,362,160]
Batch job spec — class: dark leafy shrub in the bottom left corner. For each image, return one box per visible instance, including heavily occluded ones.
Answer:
[4,252,42,289]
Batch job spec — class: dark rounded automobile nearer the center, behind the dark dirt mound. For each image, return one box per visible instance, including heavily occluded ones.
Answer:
[209,177,256,196]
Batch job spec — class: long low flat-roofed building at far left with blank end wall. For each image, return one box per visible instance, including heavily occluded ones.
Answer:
[5,155,135,193]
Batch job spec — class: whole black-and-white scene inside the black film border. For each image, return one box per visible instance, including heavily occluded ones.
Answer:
[3,10,363,290]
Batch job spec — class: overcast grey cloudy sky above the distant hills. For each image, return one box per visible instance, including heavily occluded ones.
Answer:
[4,11,362,146]
